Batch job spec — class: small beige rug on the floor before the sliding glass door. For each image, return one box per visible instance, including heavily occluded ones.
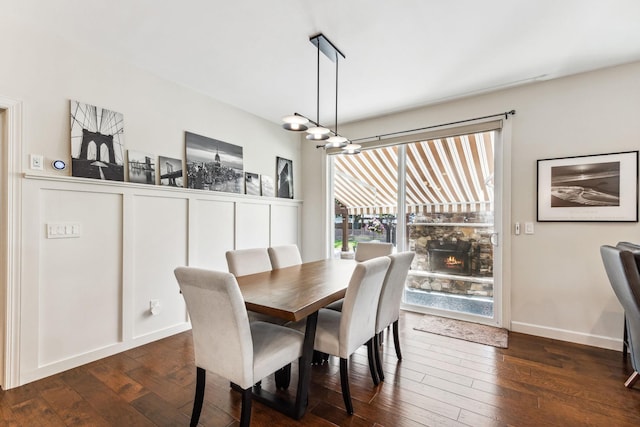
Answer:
[413,314,509,348]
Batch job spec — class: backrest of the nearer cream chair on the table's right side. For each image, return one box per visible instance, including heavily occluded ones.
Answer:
[338,257,391,358]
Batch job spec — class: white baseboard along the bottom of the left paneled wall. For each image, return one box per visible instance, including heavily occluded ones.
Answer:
[16,322,191,387]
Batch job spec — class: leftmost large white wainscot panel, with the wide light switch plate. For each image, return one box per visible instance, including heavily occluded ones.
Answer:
[39,190,122,366]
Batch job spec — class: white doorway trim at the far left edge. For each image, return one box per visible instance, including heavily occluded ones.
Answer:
[0,96,22,390]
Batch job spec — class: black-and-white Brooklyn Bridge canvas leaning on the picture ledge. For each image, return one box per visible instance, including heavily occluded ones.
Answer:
[70,101,124,181]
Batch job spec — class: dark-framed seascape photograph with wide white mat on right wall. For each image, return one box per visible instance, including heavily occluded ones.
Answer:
[537,151,638,222]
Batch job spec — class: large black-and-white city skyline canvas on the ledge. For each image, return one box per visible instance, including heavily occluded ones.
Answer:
[185,132,244,194]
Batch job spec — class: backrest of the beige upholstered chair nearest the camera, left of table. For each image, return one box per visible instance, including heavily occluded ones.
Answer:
[174,267,254,388]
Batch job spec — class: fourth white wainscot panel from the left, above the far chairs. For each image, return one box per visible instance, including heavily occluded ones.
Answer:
[236,202,271,249]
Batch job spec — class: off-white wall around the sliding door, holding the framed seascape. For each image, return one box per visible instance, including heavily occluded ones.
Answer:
[303,63,640,349]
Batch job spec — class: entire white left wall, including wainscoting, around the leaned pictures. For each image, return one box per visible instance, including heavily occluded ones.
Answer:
[0,16,302,386]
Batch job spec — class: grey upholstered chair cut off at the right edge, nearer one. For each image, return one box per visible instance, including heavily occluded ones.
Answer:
[600,245,640,387]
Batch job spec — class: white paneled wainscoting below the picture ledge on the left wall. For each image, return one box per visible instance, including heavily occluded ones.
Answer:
[12,175,302,384]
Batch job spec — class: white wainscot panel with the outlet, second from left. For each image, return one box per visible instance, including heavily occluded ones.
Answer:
[132,196,188,337]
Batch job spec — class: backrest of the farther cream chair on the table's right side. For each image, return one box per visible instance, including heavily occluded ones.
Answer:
[376,252,416,333]
